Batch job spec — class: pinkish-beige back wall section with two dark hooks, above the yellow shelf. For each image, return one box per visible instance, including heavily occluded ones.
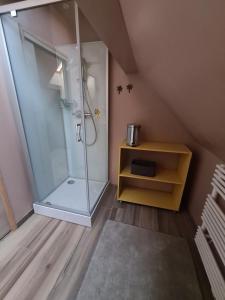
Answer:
[109,57,192,183]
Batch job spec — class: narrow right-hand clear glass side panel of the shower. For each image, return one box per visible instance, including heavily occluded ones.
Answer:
[79,10,108,210]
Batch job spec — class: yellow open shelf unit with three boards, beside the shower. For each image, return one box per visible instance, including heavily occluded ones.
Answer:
[117,143,192,211]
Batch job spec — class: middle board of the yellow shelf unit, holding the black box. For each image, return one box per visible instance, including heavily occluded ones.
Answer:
[120,166,183,184]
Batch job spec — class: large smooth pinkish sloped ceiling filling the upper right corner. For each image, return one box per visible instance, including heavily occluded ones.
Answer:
[120,0,225,160]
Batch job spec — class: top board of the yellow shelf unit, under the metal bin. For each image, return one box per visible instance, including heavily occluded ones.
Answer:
[121,142,191,155]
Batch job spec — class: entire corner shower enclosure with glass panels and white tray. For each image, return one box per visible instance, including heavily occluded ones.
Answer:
[1,1,108,226]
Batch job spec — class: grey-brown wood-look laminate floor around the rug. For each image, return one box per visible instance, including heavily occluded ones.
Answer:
[0,186,213,300]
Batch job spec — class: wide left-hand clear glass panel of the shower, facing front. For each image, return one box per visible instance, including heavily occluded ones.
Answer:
[2,1,89,214]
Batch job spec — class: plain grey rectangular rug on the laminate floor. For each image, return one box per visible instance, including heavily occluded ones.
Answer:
[77,221,202,300]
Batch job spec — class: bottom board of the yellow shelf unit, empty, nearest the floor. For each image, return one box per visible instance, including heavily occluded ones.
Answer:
[118,186,178,210]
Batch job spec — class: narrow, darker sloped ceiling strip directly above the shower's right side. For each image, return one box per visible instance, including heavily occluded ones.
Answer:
[77,0,137,73]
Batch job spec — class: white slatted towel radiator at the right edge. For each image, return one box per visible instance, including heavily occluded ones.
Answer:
[195,165,225,300]
